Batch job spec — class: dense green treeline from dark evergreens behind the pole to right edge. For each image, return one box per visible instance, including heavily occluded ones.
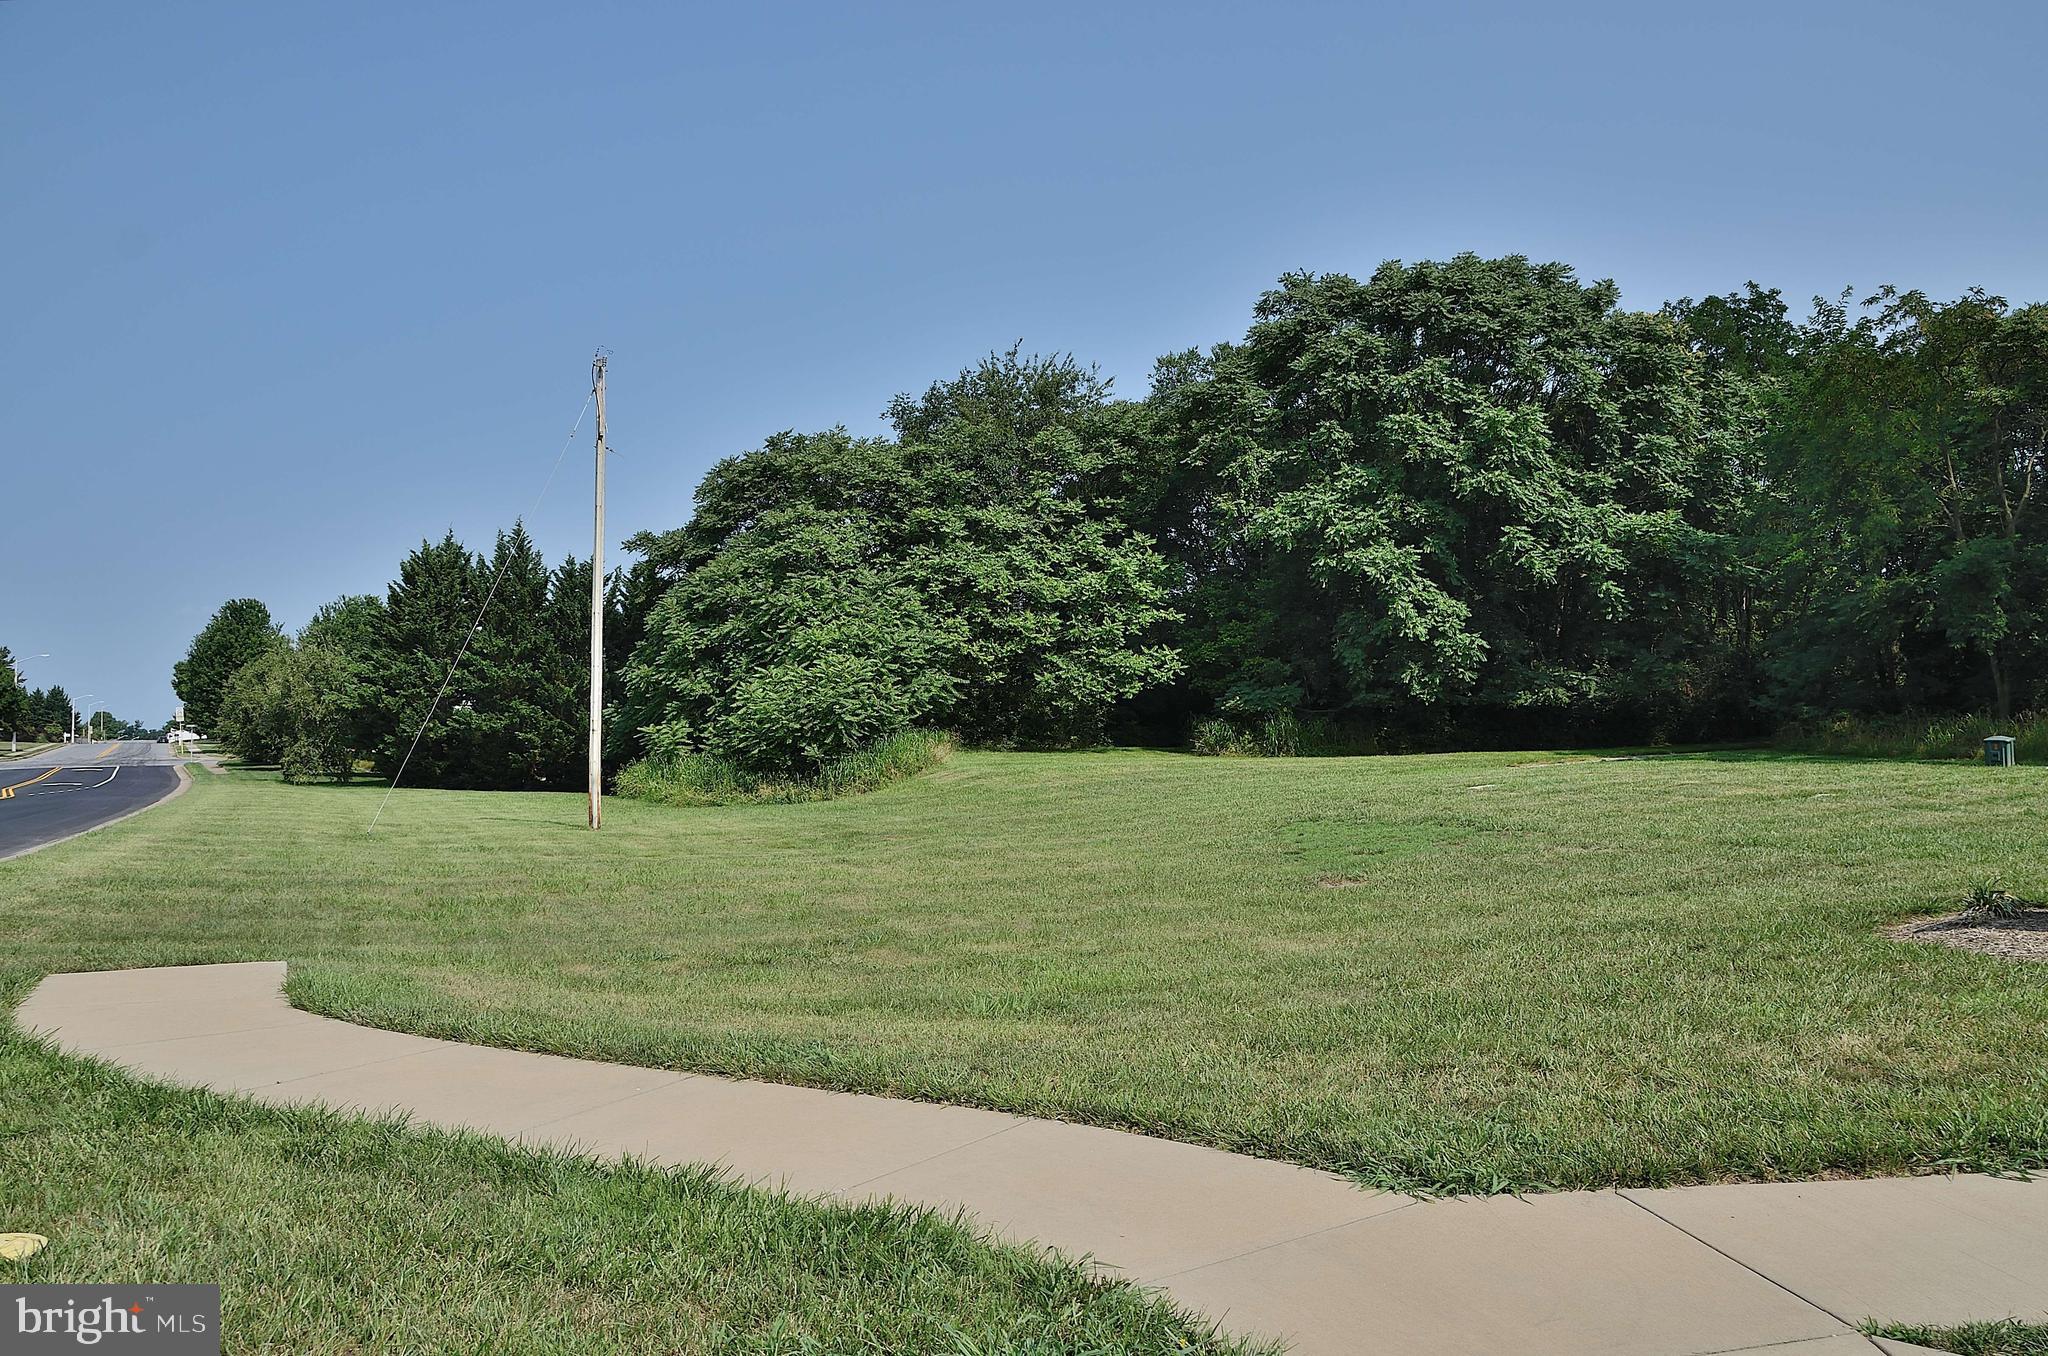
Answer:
[180,256,2048,785]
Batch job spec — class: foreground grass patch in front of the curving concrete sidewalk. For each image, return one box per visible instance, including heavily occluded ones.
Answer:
[0,985,1253,1356]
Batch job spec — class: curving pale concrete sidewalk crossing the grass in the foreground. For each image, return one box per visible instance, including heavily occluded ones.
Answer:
[18,963,2048,1356]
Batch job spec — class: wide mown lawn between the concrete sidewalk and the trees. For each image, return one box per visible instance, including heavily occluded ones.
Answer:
[0,752,2048,1190]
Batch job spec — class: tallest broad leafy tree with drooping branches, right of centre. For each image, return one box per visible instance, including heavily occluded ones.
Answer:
[1159,254,1733,737]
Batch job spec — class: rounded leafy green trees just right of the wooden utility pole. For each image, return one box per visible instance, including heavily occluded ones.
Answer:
[621,350,1178,774]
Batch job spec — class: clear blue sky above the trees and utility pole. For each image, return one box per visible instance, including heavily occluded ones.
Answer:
[0,0,2048,721]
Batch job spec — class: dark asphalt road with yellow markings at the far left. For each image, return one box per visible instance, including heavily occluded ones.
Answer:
[0,739,180,858]
